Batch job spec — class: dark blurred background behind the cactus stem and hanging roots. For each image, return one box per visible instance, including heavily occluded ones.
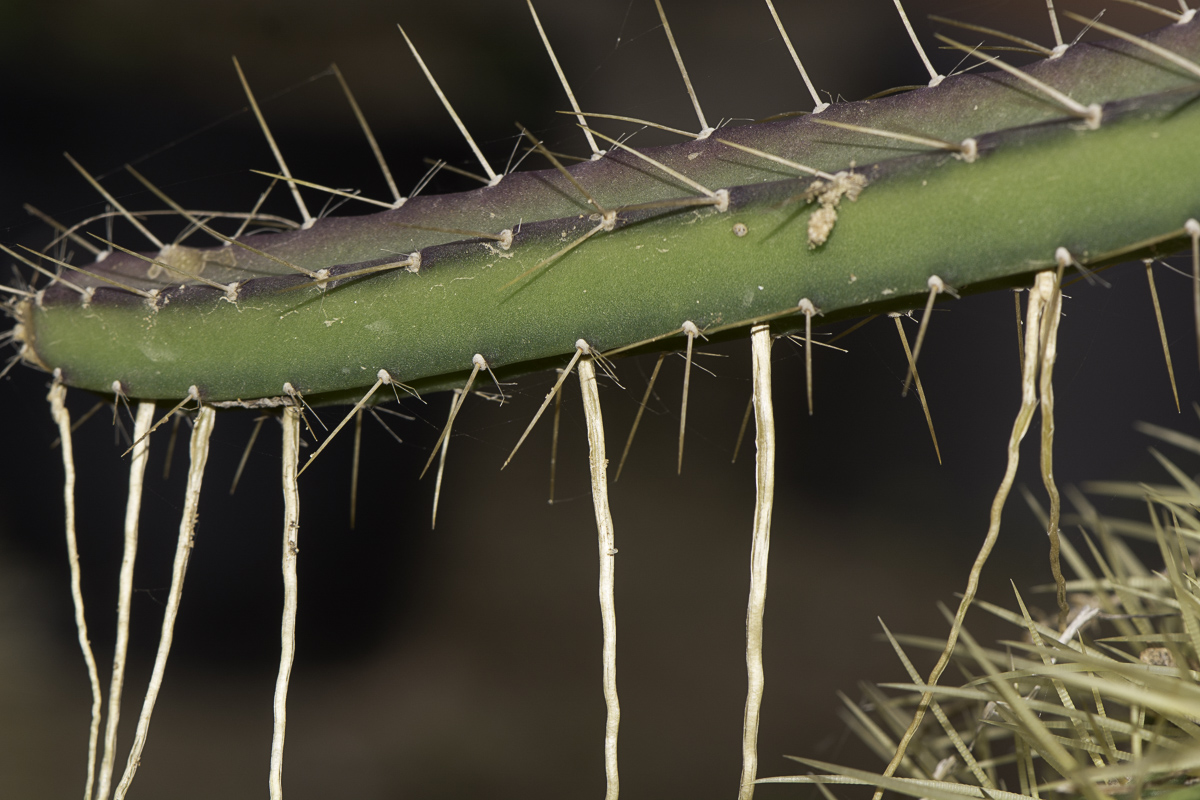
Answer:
[0,0,1200,799]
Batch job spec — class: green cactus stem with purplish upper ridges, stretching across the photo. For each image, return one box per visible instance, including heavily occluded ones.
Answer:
[14,24,1200,401]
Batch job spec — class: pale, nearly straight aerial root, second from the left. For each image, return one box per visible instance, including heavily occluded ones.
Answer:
[95,402,154,800]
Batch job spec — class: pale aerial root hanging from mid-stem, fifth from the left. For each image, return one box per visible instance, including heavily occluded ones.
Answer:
[578,357,620,800]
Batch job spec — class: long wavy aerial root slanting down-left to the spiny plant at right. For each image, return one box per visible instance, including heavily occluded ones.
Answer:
[872,270,1061,800]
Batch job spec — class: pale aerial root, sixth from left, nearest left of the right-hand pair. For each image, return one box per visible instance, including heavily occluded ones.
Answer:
[738,325,775,800]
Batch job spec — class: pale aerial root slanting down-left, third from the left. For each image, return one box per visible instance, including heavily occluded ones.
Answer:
[113,405,216,800]
